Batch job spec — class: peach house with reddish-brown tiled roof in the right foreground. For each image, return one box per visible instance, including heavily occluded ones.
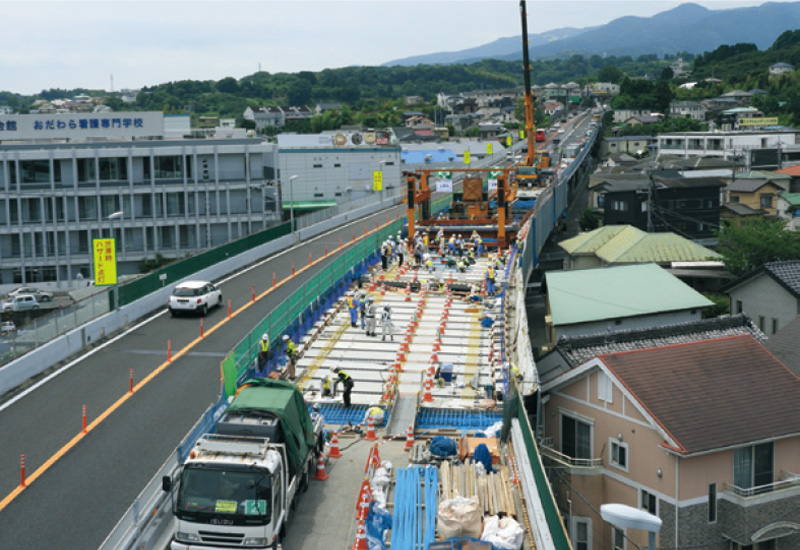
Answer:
[537,335,800,550]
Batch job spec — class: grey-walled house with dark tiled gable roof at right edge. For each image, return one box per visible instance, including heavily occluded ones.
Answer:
[723,260,800,335]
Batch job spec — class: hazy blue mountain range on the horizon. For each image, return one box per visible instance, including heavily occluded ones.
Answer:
[384,2,800,66]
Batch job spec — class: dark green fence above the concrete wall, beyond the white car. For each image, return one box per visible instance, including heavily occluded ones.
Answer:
[117,222,290,306]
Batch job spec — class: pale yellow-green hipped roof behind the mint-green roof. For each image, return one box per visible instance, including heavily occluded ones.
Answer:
[558,225,722,269]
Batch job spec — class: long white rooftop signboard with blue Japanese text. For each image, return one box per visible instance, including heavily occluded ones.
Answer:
[0,111,164,141]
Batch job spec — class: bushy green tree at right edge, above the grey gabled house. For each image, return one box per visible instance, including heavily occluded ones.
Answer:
[717,218,800,277]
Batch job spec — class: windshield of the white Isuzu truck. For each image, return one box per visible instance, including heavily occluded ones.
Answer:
[176,467,272,524]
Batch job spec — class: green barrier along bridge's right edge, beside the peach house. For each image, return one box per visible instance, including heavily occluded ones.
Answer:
[501,382,572,550]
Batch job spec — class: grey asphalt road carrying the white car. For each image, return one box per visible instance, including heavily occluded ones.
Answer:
[0,207,404,550]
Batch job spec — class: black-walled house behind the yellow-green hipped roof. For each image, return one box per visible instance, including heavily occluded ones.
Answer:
[593,175,725,239]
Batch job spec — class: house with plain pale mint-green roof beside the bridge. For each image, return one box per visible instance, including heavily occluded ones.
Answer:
[543,264,713,347]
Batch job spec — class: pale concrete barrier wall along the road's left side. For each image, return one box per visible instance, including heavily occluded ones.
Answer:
[0,198,399,395]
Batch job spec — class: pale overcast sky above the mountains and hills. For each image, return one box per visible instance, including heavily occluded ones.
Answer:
[0,0,792,95]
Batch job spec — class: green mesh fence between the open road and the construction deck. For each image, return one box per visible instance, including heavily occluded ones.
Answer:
[221,219,404,396]
